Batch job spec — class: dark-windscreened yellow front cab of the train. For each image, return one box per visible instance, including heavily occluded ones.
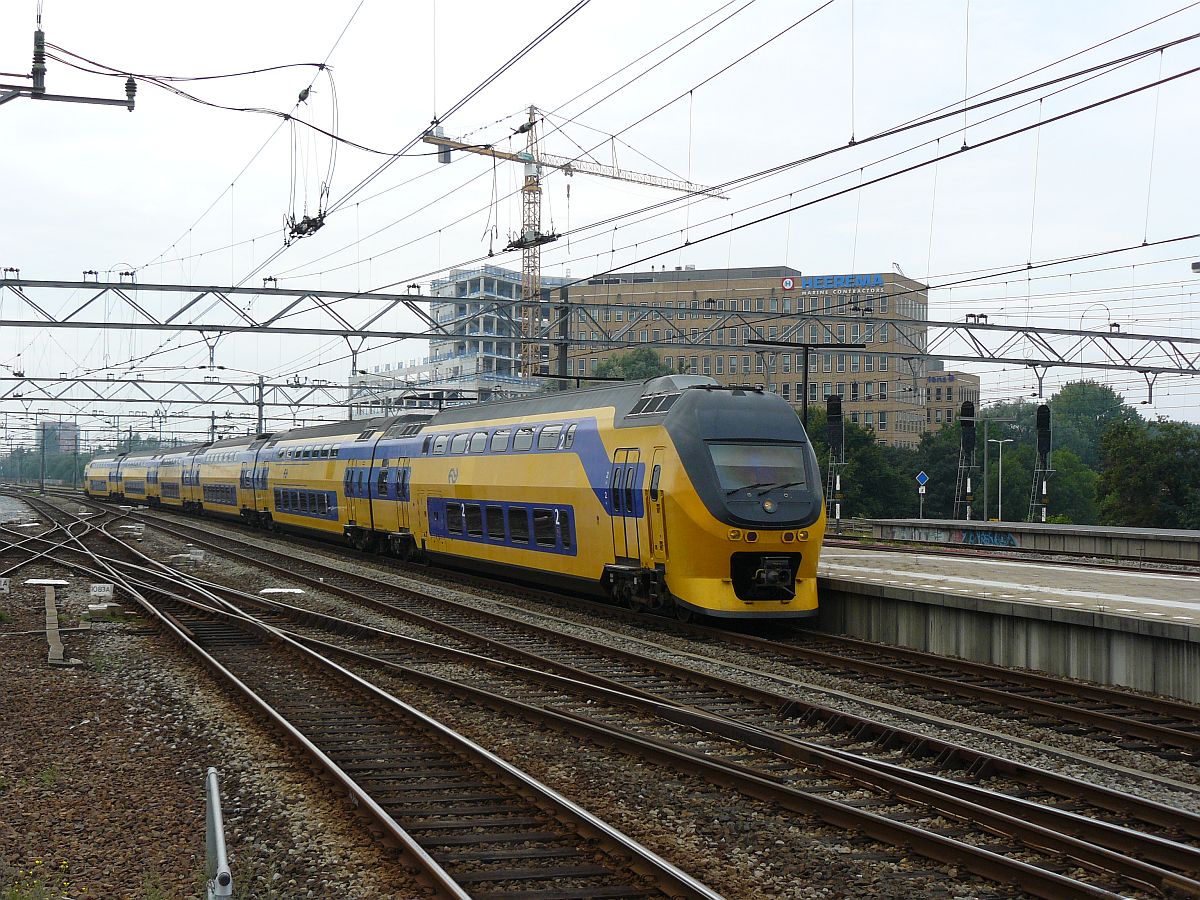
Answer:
[628,389,824,618]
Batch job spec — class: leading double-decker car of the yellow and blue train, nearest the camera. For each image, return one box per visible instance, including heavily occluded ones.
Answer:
[367,376,824,618]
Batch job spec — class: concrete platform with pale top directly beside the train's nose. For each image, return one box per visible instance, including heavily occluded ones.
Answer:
[816,547,1200,702]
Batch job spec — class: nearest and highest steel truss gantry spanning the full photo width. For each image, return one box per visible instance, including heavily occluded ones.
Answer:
[0,278,1200,391]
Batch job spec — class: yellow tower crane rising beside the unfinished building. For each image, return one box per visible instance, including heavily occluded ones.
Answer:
[424,107,722,378]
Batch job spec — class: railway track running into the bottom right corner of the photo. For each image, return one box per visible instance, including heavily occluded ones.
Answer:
[18,501,1200,896]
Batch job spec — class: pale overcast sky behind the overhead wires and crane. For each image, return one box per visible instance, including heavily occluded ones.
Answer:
[0,0,1200,444]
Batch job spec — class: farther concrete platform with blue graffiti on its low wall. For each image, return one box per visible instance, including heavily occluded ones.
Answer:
[869,518,1200,563]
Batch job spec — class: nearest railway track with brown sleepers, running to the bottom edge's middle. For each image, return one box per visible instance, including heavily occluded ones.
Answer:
[7,501,719,900]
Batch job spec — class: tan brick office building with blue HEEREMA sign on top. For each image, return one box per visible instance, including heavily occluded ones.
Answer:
[566,266,945,446]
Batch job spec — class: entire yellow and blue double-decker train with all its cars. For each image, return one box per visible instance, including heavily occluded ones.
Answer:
[84,376,824,618]
